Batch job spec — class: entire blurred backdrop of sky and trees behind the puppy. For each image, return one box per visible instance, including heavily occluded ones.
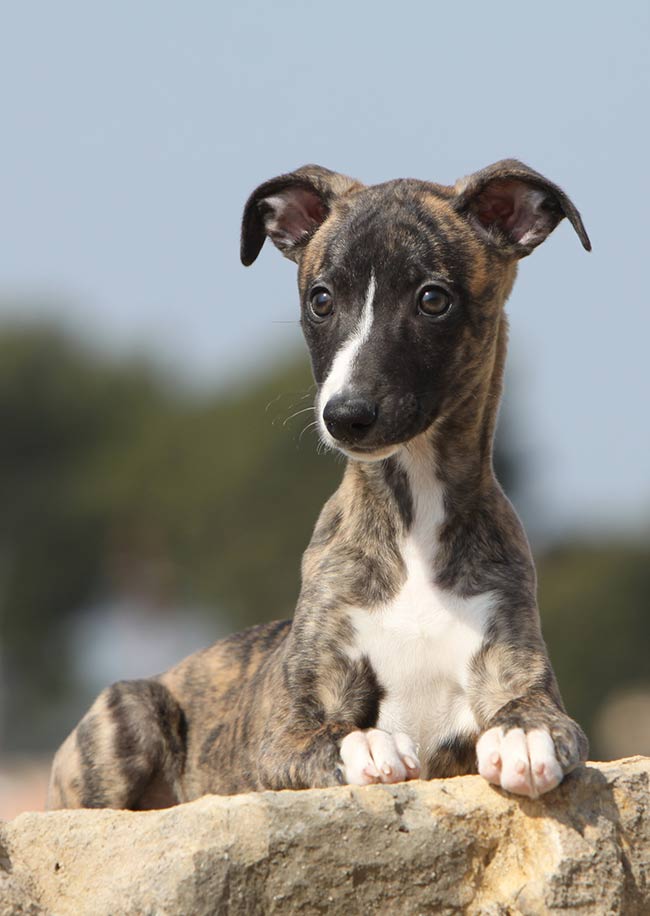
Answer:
[0,0,650,817]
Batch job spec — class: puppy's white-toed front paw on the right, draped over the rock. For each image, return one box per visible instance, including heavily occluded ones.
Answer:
[476,727,563,798]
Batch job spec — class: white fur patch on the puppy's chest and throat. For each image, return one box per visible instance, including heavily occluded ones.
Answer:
[350,456,495,764]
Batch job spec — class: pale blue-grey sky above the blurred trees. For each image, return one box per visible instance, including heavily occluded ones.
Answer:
[0,0,650,534]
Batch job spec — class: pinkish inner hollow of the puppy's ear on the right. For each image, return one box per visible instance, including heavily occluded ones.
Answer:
[475,179,555,244]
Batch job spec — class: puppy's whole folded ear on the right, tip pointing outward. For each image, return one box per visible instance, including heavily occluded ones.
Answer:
[455,159,591,258]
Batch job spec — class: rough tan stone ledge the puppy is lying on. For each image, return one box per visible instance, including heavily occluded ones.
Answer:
[0,757,650,916]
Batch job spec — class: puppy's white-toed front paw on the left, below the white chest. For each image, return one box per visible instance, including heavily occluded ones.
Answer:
[341,728,420,786]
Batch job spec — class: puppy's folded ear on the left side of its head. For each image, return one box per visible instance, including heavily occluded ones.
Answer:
[241,165,363,267]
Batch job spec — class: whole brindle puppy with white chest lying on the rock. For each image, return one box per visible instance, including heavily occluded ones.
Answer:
[48,160,590,808]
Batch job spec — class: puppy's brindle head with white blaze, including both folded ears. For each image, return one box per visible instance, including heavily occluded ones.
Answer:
[242,161,590,460]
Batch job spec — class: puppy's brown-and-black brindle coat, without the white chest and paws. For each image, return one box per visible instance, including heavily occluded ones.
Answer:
[48,160,590,808]
